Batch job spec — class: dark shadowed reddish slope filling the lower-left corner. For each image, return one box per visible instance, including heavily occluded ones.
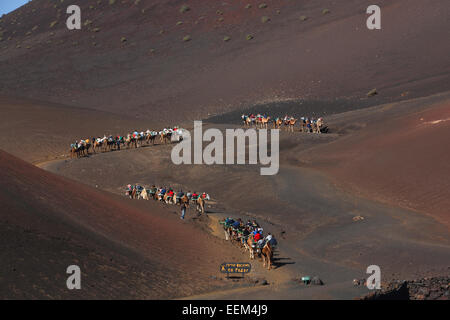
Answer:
[0,151,237,299]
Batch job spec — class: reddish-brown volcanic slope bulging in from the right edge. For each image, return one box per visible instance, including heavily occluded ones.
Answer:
[310,94,450,227]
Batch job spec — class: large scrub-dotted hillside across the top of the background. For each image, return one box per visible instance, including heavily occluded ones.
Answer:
[0,0,450,120]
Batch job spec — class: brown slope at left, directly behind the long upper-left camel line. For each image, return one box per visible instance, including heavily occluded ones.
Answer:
[0,96,162,163]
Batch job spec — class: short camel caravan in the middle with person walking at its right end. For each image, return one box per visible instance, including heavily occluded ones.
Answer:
[125,184,211,215]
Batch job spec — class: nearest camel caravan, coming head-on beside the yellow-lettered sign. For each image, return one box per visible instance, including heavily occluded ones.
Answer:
[220,217,278,270]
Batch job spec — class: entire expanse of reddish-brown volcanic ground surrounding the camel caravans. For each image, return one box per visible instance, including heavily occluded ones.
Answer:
[0,0,450,299]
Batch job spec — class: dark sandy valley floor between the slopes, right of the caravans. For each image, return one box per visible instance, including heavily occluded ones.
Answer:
[38,94,450,299]
